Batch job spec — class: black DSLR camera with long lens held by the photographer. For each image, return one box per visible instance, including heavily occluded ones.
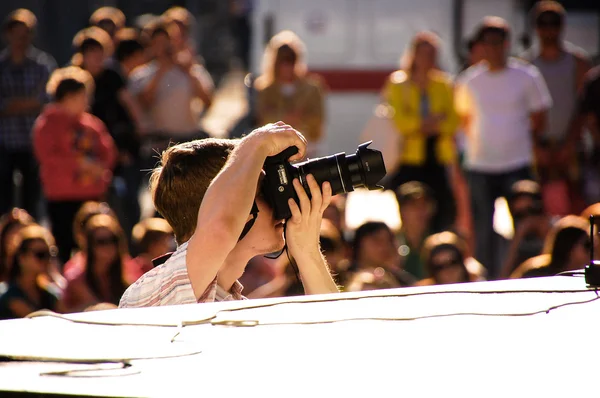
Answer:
[261,141,386,220]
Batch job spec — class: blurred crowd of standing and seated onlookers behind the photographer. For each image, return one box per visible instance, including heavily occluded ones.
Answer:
[0,1,600,319]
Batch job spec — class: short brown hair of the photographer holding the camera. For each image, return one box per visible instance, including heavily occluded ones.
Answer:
[150,138,238,244]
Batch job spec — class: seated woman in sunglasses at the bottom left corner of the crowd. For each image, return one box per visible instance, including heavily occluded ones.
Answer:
[0,224,64,319]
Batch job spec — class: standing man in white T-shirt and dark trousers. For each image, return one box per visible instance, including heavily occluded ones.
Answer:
[456,17,552,278]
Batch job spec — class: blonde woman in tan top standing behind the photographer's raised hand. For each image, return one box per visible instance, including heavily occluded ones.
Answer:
[255,30,325,157]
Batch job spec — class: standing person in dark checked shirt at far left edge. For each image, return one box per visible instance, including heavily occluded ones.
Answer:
[0,8,56,218]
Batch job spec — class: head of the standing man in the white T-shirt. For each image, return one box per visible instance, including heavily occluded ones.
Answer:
[475,17,510,67]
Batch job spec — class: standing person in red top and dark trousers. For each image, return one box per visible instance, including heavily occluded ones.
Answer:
[33,66,117,263]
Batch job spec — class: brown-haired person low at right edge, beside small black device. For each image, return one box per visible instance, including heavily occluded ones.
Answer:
[510,215,592,279]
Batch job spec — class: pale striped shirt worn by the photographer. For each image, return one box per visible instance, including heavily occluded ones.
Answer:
[119,242,246,308]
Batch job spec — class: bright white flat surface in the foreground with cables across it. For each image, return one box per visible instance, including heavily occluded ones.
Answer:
[0,277,600,397]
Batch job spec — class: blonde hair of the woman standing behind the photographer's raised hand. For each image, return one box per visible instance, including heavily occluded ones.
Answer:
[256,30,307,90]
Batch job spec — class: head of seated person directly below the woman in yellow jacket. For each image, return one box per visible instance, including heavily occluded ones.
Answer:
[396,181,436,230]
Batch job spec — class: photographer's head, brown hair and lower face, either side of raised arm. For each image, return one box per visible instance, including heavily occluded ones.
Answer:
[150,138,285,254]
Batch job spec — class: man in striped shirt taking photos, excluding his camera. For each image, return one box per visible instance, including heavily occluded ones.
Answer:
[120,122,338,307]
